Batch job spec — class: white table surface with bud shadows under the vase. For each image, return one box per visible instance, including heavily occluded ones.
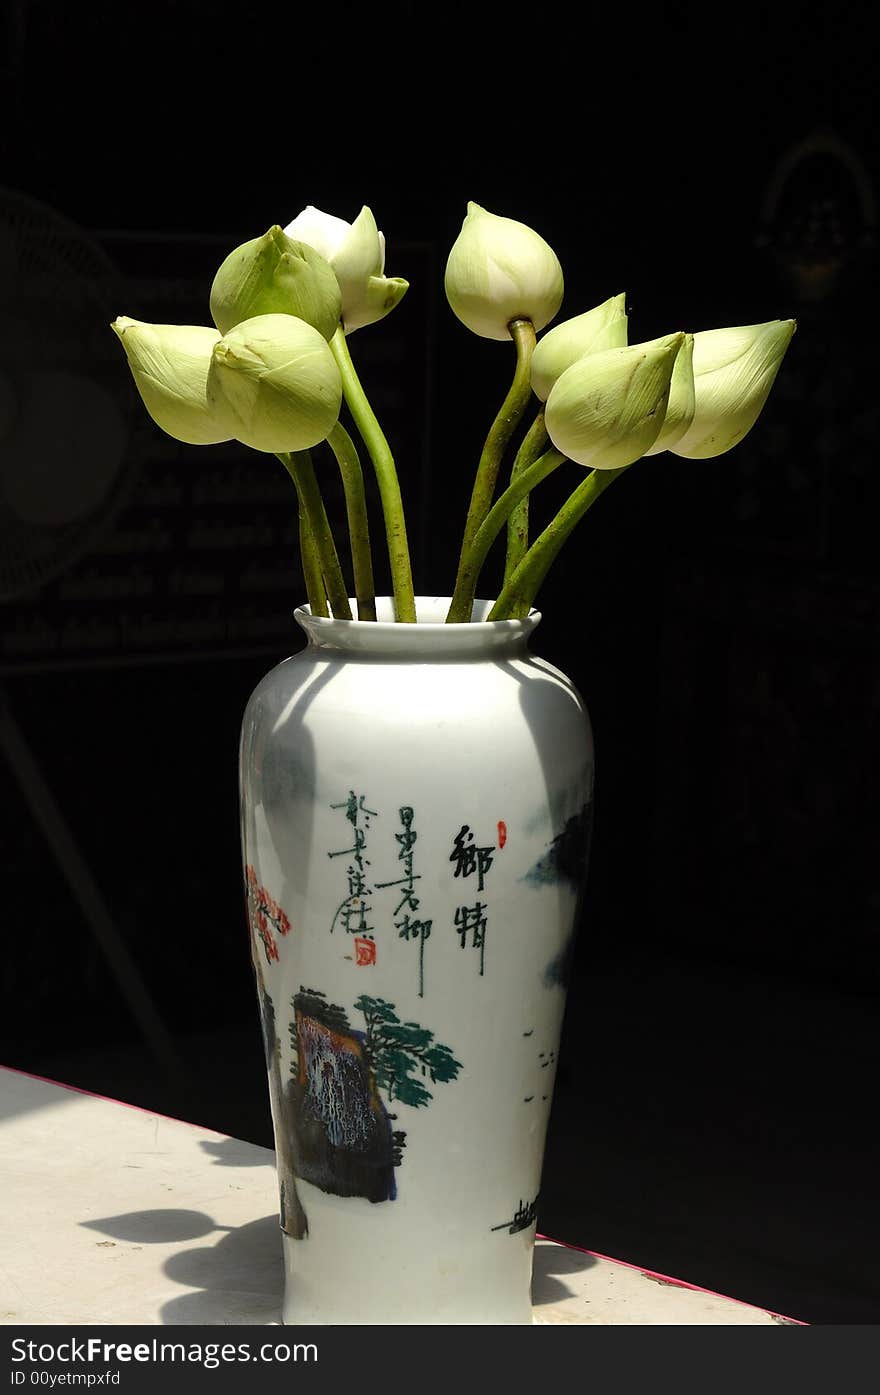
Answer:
[0,1067,791,1325]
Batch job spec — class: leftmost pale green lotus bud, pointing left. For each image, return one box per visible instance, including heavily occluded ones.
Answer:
[110,315,236,445]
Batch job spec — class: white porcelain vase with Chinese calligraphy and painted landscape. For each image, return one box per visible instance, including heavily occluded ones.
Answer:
[240,597,593,1324]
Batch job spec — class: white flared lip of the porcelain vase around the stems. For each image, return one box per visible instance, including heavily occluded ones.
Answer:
[293,596,541,658]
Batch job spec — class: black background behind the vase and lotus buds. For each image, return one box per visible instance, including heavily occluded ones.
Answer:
[0,0,880,1322]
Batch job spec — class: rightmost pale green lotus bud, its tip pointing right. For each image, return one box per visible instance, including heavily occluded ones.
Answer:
[668,319,796,460]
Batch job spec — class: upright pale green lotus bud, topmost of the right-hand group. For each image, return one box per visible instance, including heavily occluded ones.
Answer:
[445,204,563,339]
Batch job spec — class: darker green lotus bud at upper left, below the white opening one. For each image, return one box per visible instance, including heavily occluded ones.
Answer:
[211,225,342,339]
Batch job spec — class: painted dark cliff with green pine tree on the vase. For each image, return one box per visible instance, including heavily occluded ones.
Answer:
[286,988,462,1201]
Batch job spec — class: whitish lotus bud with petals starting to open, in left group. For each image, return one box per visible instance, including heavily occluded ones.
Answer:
[285,205,409,335]
